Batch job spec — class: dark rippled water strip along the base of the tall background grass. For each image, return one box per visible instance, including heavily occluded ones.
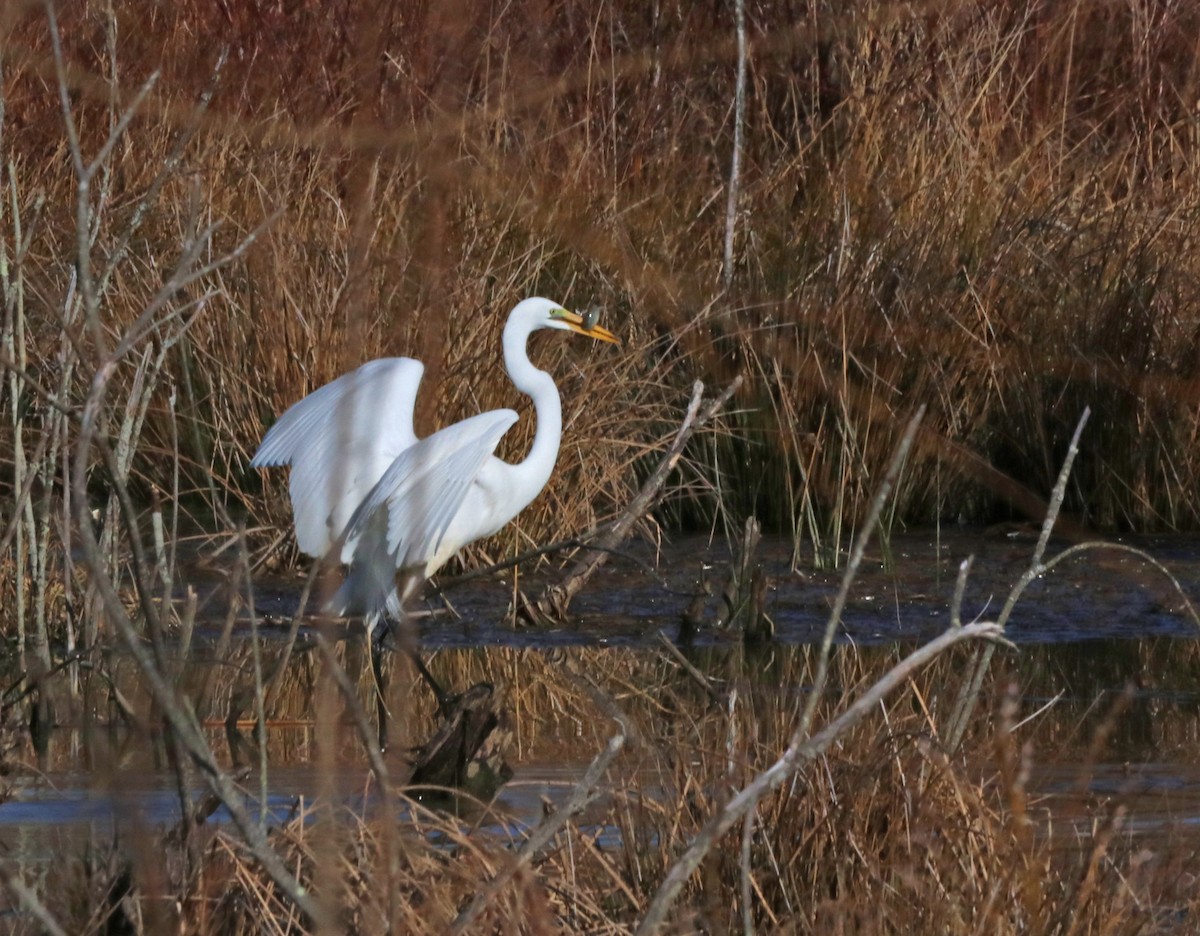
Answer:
[241,528,1200,648]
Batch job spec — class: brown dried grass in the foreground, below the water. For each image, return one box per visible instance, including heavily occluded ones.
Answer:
[17,648,1195,934]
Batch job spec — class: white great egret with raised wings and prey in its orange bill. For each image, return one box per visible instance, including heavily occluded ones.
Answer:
[251,299,620,631]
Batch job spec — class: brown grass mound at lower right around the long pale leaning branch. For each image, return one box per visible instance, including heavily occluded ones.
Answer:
[597,653,1152,934]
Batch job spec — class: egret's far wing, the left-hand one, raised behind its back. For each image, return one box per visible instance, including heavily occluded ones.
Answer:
[251,358,425,558]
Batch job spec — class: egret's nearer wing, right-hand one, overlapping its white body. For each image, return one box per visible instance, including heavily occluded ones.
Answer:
[342,409,517,572]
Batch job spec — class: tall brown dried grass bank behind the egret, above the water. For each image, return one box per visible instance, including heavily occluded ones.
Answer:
[7,2,1200,609]
